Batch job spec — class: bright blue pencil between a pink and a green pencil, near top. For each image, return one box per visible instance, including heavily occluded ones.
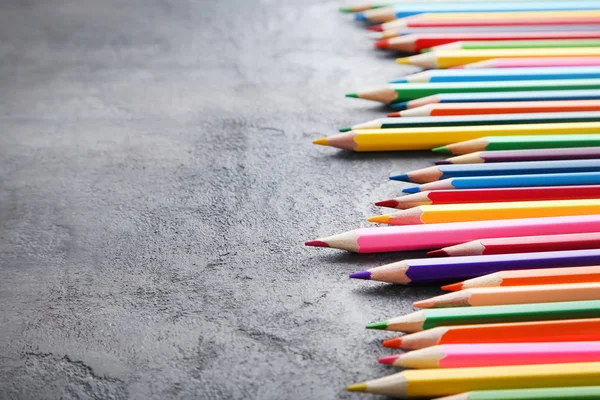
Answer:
[390,67,600,84]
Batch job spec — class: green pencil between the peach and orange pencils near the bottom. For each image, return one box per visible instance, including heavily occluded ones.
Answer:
[367,300,600,333]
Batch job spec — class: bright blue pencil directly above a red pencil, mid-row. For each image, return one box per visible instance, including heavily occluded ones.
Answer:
[402,172,600,193]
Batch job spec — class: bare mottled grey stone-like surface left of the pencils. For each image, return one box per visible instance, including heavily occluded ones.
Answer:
[0,0,435,400]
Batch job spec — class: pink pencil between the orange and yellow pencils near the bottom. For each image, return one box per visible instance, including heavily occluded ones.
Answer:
[379,342,600,369]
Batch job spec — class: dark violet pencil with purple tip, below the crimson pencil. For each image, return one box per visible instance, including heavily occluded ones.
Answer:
[350,249,600,285]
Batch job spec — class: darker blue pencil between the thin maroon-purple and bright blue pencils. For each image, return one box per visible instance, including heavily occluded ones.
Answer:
[390,159,600,183]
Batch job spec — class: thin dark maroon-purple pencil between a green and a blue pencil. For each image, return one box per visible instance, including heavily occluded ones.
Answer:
[436,147,600,165]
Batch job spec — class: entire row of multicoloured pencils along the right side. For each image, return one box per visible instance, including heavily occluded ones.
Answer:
[306,0,600,400]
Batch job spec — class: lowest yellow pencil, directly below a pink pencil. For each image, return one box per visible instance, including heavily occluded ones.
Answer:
[346,362,600,398]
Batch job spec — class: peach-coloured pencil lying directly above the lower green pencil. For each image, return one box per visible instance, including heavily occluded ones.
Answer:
[413,282,600,308]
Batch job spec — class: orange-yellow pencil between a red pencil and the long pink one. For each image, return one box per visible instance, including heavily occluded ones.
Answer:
[369,199,600,225]
